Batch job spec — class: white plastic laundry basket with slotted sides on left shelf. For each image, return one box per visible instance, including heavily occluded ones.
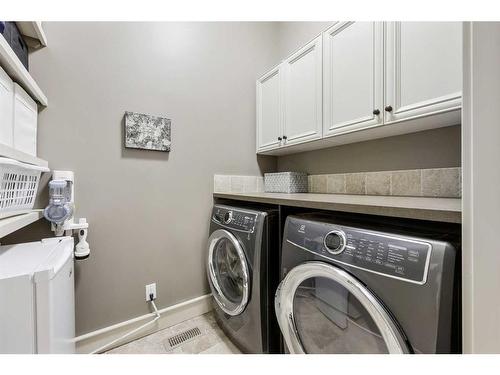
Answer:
[0,157,49,217]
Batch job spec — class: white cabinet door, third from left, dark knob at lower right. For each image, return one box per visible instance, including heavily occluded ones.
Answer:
[323,22,384,136]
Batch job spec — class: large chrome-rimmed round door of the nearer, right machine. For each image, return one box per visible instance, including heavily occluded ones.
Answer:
[276,262,408,354]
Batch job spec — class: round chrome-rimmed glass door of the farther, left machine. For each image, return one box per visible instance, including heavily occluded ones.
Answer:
[208,229,250,315]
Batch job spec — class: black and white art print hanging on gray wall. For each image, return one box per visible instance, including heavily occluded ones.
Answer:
[125,112,172,152]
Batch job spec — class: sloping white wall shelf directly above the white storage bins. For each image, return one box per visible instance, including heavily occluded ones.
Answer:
[0,36,48,107]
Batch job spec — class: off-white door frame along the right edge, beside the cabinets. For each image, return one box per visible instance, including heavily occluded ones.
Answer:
[462,22,500,353]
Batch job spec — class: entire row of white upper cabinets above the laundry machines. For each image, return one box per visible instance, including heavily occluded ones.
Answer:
[257,22,462,155]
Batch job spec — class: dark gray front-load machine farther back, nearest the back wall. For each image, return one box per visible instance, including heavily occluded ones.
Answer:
[207,204,280,353]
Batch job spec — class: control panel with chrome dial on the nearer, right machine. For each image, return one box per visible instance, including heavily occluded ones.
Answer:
[285,217,432,284]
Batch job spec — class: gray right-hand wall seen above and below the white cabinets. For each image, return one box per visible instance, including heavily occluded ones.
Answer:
[278,22,461,174]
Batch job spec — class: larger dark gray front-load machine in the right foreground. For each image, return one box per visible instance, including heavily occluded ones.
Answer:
[275,215,458,354]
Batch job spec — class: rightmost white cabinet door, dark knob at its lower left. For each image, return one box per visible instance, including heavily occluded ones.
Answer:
[384,22,462,123]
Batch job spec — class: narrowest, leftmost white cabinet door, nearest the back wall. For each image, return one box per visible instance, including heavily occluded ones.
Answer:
[256,65,283,152]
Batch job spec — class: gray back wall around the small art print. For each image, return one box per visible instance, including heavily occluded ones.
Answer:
[21,23,278,334]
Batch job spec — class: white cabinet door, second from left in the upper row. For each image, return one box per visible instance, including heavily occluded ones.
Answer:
[283,36,323,144]
